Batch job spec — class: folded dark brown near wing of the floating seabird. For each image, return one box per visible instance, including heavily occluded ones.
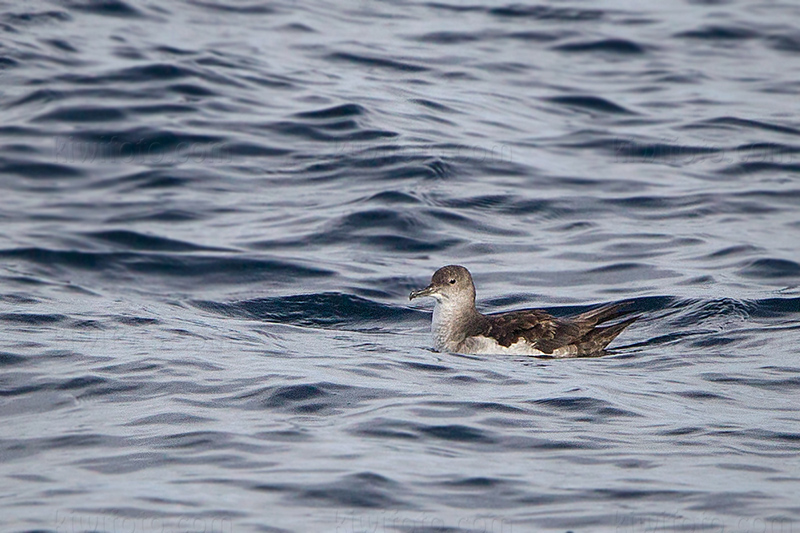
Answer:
[486,309,585,354]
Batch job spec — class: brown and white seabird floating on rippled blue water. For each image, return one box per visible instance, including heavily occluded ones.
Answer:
[408,265,639,357]
